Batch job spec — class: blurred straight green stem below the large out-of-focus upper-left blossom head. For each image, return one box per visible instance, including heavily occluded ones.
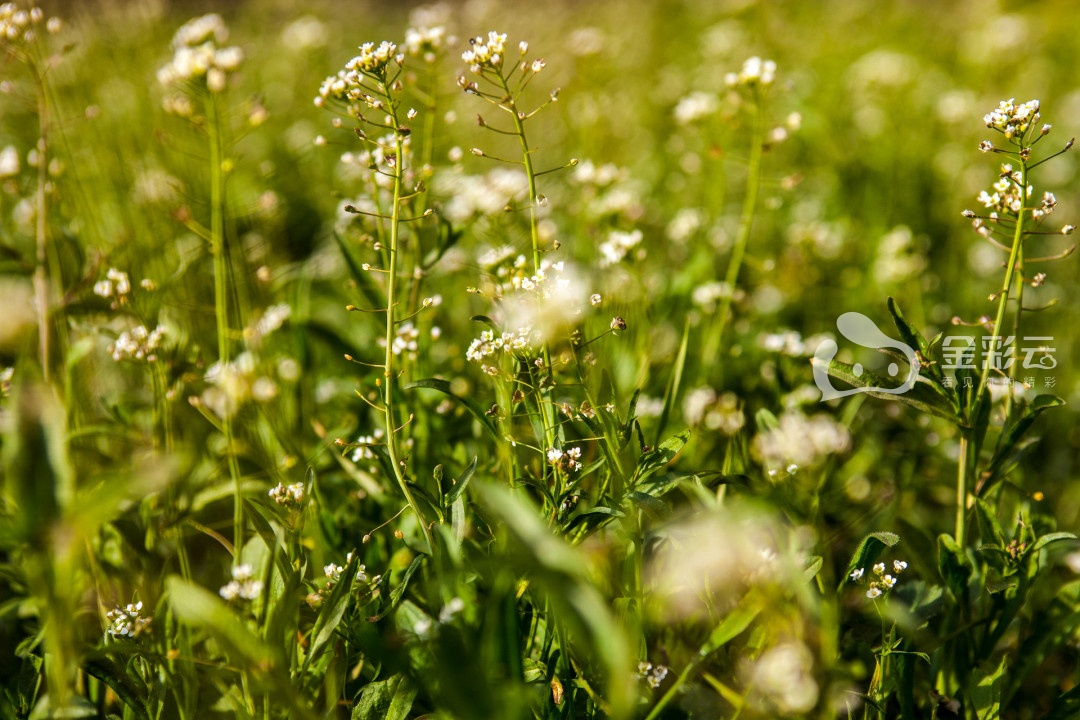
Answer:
[206,94,244,565]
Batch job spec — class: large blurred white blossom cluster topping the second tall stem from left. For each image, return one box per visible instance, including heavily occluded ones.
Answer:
[158,13,244,97]
